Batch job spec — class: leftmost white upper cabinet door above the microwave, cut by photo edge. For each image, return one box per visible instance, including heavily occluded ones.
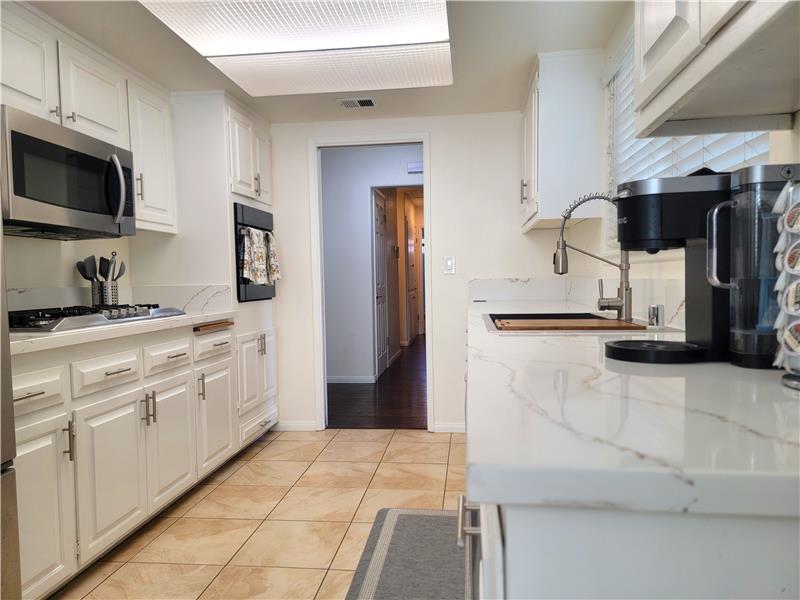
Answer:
[0,6,61,123]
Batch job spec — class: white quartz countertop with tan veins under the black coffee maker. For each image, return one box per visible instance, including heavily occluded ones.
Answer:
[466,301,800,517]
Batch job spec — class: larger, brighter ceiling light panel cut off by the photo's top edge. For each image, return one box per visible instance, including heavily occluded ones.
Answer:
[142,0,450,56]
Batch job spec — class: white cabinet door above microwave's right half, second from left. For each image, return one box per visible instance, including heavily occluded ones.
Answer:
[58,40,130,149]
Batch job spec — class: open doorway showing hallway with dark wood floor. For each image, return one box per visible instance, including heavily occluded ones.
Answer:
[319,144,429,429]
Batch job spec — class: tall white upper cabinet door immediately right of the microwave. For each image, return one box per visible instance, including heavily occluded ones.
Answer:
[128,82,176,232]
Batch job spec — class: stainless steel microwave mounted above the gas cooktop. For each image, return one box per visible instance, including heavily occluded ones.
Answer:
[0,105,136,240]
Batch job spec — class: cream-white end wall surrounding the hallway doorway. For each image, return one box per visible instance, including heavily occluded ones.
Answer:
[272,112,597,429]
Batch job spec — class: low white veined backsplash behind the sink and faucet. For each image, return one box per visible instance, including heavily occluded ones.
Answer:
[469,277,686,329]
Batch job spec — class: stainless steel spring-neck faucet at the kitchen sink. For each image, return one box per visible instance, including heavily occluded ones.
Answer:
[553,194,633,322]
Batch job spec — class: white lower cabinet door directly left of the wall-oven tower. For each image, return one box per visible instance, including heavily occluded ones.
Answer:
[195,358,238,477]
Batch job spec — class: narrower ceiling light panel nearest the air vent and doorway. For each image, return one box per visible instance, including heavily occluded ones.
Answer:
[209,42,453,96]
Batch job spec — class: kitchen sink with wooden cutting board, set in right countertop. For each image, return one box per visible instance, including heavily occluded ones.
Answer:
[484,313,646,331]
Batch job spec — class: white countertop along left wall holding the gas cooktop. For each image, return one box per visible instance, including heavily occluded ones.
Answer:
[10,310,237,356]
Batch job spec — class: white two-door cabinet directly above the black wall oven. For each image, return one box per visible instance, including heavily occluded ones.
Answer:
[227,105,272,205]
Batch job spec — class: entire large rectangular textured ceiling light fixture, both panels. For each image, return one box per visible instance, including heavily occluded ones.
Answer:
[142,0,453,96]
